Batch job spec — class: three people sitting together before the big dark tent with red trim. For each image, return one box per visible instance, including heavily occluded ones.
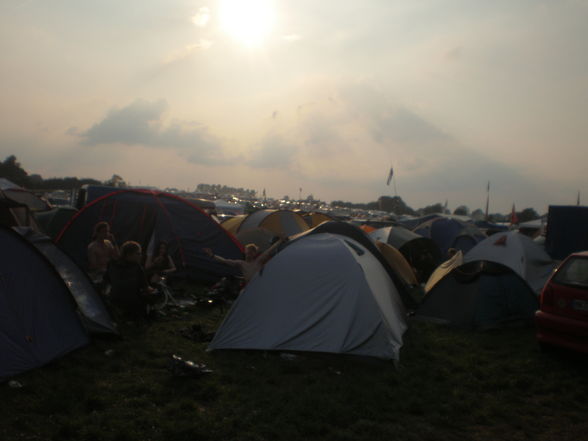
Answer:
[88,222,176,318]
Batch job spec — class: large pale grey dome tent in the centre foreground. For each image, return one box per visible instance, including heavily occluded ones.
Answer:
[209,233,406,359]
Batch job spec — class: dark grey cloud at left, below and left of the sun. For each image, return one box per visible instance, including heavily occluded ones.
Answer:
[79,99,232,165]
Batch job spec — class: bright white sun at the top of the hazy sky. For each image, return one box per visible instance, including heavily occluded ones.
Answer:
[219,0,275,48]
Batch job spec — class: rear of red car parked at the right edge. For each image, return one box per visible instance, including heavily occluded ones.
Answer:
[535,251,588,353]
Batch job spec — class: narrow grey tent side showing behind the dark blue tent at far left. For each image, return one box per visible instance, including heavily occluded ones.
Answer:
[14,227,117,334]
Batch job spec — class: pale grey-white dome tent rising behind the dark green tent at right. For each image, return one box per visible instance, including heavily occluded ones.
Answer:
[464,231,555,294]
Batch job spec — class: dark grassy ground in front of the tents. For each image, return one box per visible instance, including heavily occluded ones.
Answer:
[0,284,588,441]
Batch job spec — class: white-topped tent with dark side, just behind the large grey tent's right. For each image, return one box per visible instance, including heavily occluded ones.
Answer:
[370,226,442,282]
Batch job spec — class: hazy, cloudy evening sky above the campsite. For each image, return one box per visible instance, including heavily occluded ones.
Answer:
[0,0,588,213]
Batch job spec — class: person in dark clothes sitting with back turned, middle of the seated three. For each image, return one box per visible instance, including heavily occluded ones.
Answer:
[108,241,156,318]
